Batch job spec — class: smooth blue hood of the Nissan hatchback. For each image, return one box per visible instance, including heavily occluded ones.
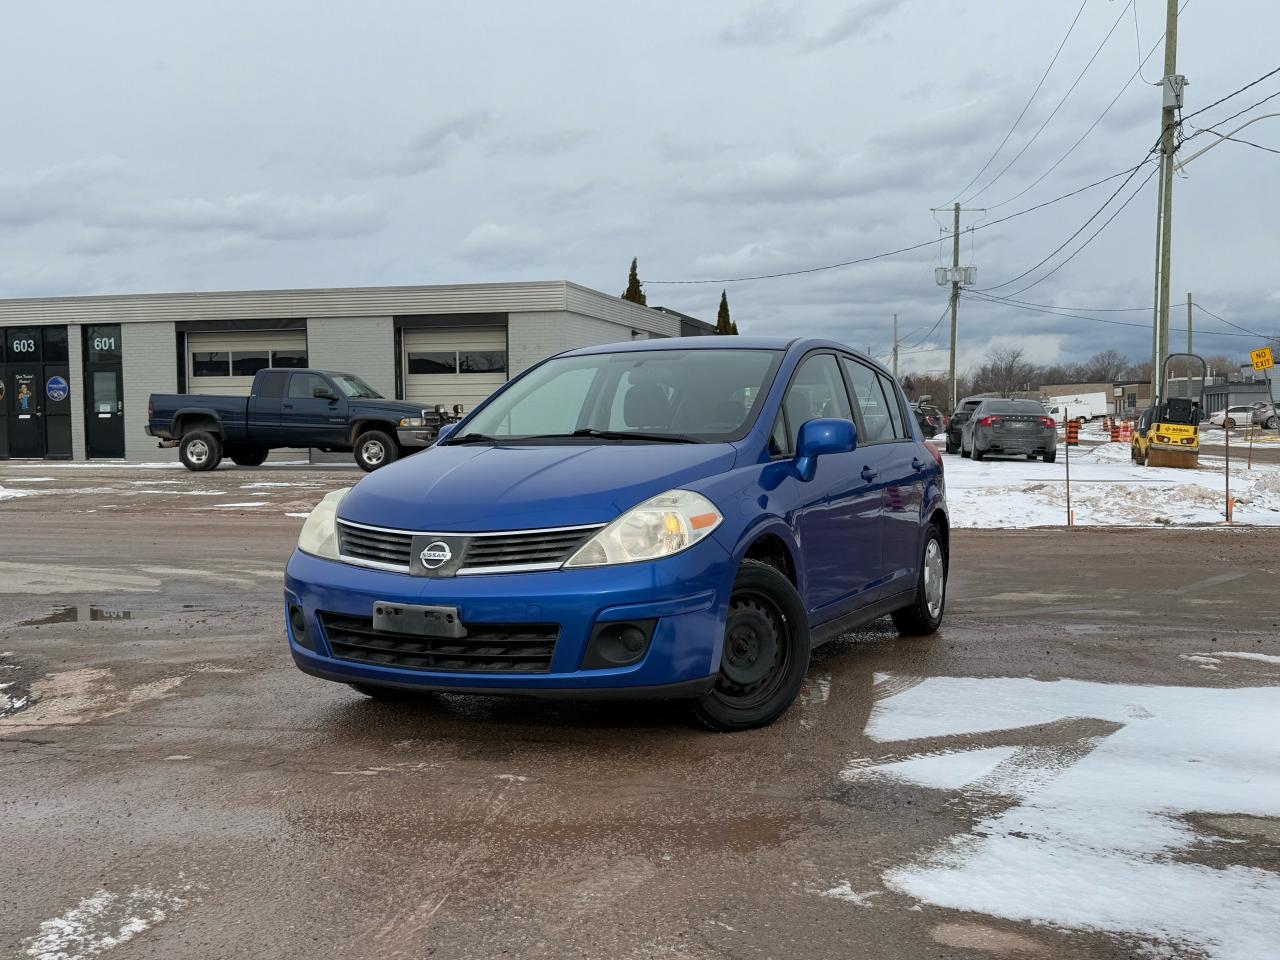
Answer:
[338,443,737,534]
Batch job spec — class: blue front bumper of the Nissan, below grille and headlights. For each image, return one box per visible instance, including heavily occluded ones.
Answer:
[284,538,733,698]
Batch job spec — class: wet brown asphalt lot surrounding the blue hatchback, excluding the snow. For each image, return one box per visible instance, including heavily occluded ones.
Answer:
[0,465,1280,957]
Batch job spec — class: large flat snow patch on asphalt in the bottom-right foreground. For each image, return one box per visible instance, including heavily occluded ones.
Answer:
[845,677,1280,960]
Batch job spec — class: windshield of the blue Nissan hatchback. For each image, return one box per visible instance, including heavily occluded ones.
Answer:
[447,348,782,444]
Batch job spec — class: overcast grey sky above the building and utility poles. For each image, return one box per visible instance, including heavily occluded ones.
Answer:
[0,0,1280,370]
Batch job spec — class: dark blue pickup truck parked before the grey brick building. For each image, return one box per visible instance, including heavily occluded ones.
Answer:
[147,369,462,471]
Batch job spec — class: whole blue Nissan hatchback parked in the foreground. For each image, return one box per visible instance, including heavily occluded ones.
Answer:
[284,337,948,730]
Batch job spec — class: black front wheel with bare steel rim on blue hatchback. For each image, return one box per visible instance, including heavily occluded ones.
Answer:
[691,559,809,732]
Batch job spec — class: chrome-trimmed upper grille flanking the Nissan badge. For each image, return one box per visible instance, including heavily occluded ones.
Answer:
[338,520,604,576]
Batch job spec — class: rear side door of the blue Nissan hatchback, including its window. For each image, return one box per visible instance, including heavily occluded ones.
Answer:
[844,357,928,596]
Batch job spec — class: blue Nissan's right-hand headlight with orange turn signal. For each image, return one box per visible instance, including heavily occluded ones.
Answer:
[564,490,724,567]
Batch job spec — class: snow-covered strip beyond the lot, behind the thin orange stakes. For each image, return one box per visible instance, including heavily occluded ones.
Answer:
[946,443,1280,529]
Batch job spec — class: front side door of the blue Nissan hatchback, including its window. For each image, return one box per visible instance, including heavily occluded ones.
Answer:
[782,353,881,623]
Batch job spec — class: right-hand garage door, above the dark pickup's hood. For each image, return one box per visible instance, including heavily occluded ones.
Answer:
[404,326,507,410]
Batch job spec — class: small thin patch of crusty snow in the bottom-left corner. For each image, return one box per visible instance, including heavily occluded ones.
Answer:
[23,887,187,960]
